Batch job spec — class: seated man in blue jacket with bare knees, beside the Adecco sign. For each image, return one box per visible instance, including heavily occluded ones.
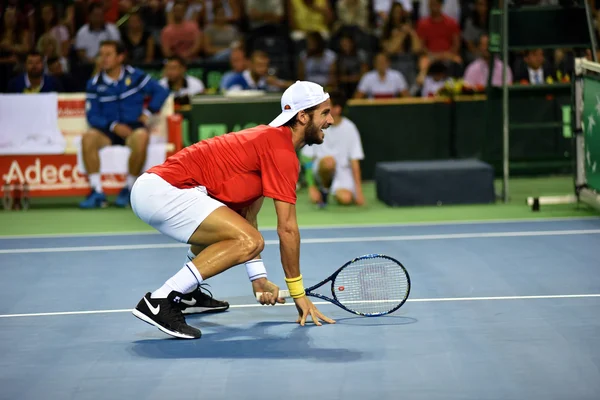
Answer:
[80,40,169,208]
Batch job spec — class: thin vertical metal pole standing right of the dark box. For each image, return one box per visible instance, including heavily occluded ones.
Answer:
[502,0,509,203]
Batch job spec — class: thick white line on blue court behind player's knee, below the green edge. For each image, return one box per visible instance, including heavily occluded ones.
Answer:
[0,229,600,254]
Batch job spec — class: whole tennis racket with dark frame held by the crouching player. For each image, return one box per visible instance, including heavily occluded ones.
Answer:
[256,254,410,317]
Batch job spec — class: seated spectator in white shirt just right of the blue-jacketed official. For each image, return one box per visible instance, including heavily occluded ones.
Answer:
[158,56,204,106]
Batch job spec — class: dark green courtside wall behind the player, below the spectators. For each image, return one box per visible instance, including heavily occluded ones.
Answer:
[183,93,576,179]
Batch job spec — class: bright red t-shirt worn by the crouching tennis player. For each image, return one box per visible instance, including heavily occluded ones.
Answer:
[147,125,300,211]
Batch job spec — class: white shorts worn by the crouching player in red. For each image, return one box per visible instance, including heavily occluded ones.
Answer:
[131,173,224,243]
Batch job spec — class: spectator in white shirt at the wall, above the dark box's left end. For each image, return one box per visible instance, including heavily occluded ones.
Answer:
[354,53,409,99]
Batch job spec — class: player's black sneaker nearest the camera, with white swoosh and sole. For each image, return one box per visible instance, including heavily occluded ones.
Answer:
[132,292,202,339]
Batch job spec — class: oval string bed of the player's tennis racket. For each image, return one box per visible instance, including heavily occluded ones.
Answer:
[333,258,410,315]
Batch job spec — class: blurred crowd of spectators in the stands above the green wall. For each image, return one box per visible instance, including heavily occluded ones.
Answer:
[0,0,589,102]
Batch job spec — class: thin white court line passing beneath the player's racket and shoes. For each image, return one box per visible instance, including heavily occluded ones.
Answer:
[0,293,600,318]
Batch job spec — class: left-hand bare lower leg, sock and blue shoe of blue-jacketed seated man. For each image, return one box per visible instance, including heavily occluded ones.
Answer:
[79,129,111,208]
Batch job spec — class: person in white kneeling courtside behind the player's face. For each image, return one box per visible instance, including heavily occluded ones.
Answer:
[301,91,365,207]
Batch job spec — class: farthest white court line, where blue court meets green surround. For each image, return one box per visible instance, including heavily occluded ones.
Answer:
[0,217,600,240]
